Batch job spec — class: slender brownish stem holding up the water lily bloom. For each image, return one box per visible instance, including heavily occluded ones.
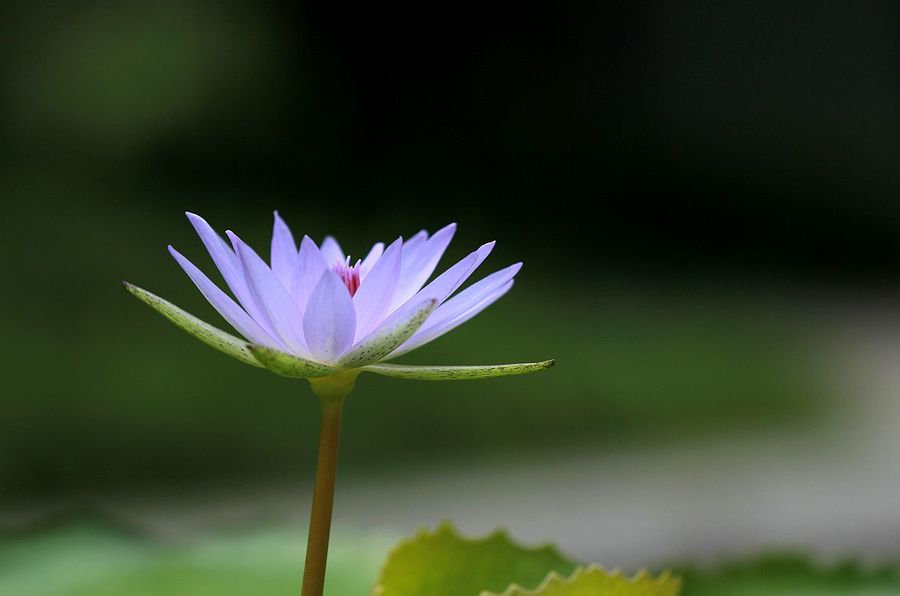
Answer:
[300,373,358,596]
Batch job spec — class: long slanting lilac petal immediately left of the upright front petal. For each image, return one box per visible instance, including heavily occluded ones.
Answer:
[225,230,308,356]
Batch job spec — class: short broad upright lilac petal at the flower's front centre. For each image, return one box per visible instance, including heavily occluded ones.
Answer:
[303,269,356,362]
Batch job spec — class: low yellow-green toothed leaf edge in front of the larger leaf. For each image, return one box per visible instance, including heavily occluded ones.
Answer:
[492,566,681,596]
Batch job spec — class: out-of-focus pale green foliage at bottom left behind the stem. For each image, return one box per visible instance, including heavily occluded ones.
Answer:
[0,521,390,596]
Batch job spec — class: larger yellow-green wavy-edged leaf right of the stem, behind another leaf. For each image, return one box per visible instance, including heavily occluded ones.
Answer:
[373,523,575,596]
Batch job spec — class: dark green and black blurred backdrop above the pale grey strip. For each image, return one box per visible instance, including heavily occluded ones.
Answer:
[0,0,900,506]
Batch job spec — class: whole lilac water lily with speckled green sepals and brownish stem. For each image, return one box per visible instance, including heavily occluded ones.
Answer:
[125,212,554,595]
